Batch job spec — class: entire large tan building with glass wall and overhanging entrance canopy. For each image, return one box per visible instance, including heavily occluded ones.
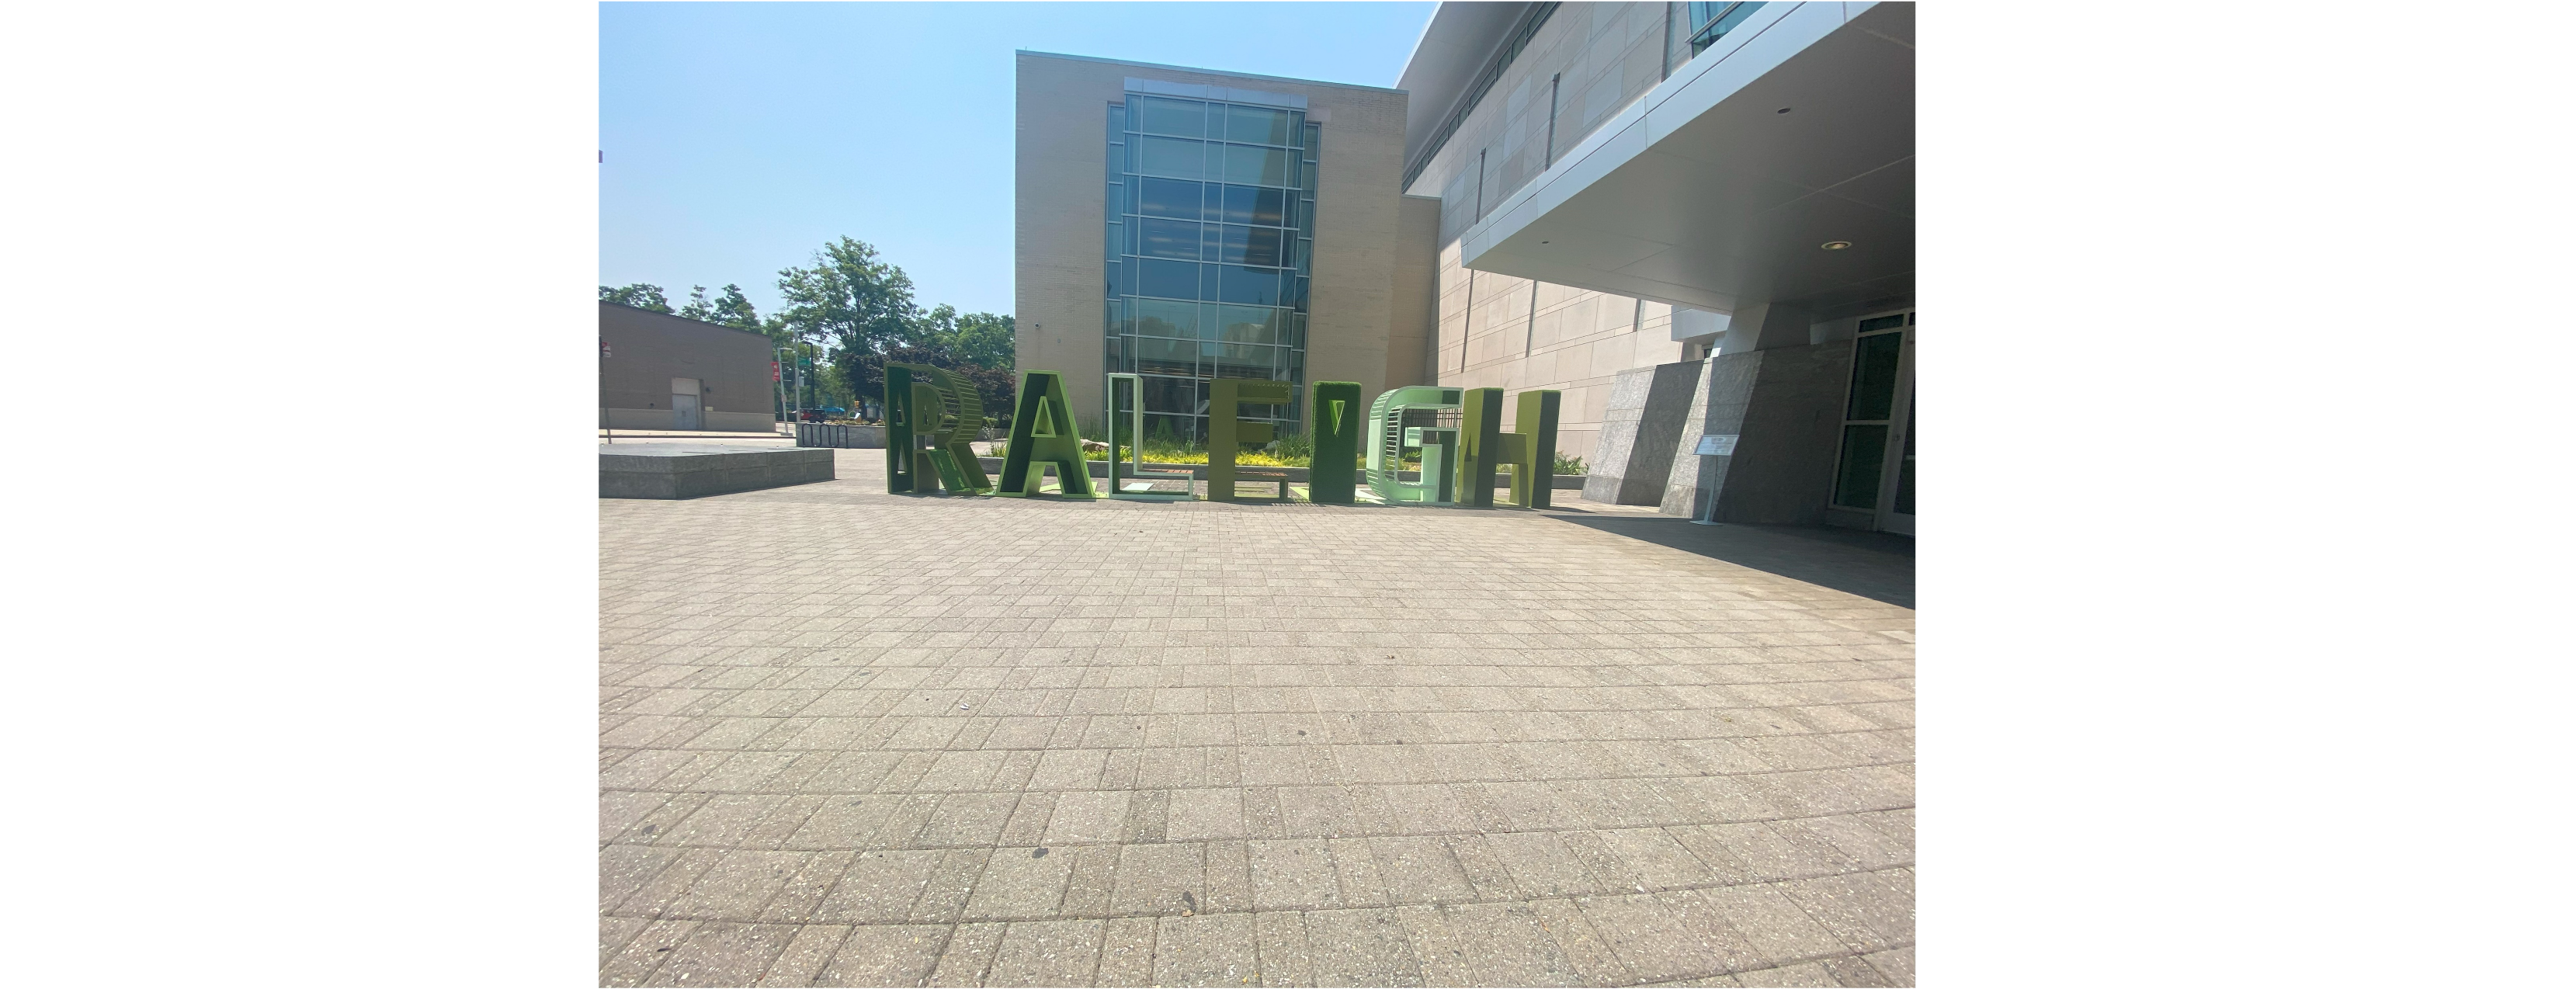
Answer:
[1015,0,1917,536]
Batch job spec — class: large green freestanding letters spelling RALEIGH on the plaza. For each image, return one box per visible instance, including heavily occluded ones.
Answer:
[886,363,1564,508]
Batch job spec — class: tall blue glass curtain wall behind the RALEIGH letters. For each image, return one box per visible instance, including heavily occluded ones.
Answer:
[1102,92,1321,443]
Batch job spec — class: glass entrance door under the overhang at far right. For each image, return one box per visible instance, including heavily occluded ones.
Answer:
[1834,311,1917,536]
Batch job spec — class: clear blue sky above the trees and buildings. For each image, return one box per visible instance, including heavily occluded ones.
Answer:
[595,0,1435,317]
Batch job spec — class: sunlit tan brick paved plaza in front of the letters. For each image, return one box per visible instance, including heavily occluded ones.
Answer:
[598,451,1914,987]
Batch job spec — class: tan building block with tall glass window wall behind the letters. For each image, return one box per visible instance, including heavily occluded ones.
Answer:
[1012,51,1440,436]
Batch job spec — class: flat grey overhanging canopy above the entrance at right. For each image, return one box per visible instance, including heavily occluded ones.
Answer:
[1460,2,1914,311]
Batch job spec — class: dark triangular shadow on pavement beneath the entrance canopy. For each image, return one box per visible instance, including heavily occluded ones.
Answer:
[1548,512,1914,608]
